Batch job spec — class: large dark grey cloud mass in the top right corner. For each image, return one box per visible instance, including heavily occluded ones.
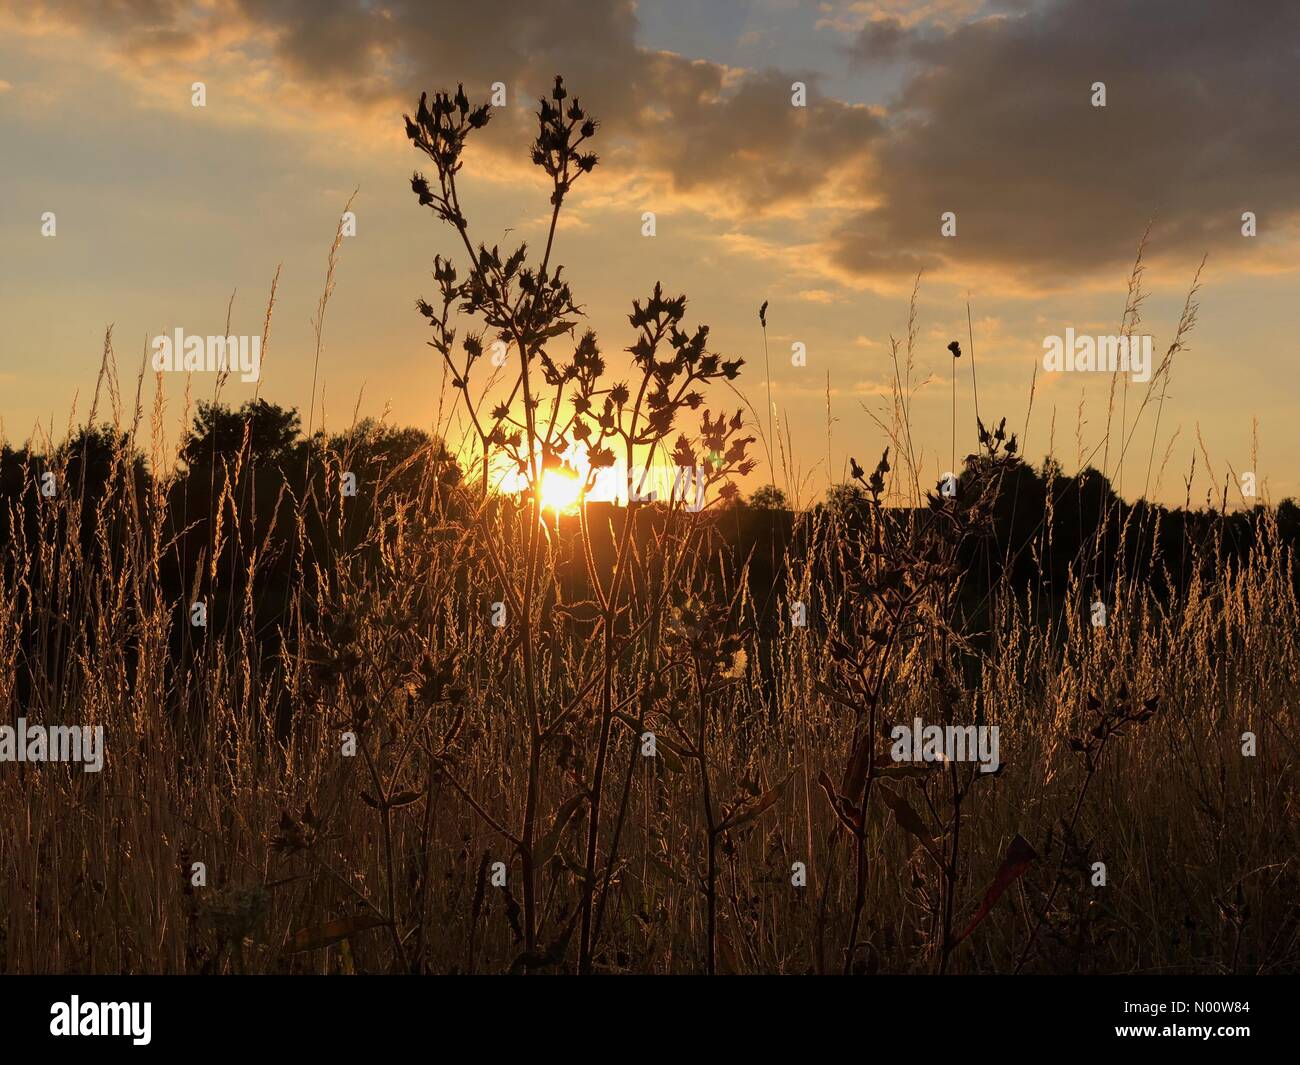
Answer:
[831,0,1300,282]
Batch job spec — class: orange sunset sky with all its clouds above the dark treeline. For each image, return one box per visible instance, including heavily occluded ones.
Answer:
[0,0,1300,506]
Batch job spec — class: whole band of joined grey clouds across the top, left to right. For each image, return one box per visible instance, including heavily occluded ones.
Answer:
[12,0,1300,283]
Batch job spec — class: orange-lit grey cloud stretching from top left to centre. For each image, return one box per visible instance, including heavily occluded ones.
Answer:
[17,0,883,211]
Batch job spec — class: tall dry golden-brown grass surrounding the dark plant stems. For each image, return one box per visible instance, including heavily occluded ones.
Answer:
[0,392,1300,973]
